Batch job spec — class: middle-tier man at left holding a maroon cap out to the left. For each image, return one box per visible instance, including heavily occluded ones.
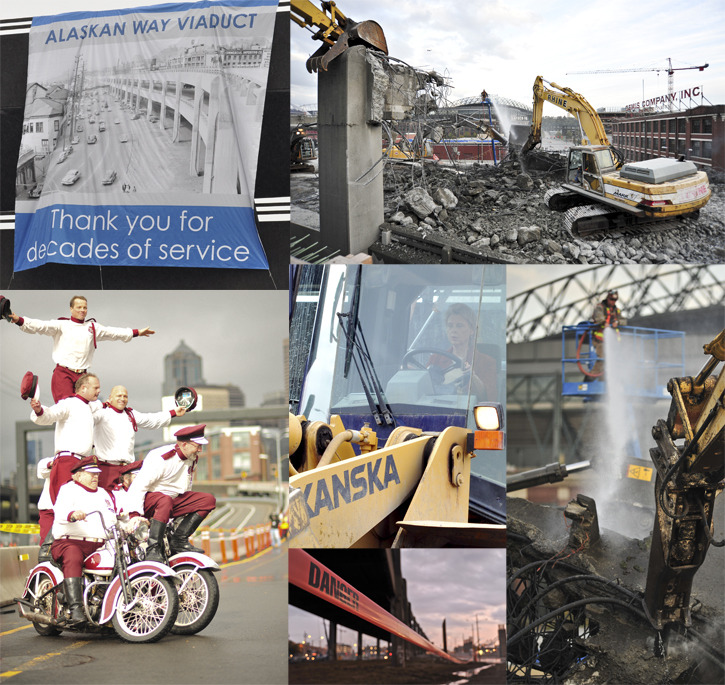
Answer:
[30,373,101,561]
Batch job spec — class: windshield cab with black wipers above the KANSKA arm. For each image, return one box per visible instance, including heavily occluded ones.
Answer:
[290,265,506,483]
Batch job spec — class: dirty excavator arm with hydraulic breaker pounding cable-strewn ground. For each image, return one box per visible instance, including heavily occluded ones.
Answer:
[644,330,725,630]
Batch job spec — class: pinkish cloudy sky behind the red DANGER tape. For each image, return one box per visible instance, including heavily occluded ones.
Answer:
[289,549,506,650]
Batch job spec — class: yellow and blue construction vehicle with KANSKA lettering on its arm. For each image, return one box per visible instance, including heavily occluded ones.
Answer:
[288,265,506,548]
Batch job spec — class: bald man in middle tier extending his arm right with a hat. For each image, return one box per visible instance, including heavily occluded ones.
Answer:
[93,385,186,488]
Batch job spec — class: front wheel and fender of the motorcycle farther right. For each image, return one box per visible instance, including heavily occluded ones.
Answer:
[164,520,221,635]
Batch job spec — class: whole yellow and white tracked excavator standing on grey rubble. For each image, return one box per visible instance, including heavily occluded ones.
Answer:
[521,76,711,236]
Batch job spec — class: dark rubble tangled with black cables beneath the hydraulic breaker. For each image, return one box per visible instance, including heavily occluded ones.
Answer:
[506,497,725,685]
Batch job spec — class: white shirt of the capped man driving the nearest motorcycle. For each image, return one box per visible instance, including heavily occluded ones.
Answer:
[53,480,116,540]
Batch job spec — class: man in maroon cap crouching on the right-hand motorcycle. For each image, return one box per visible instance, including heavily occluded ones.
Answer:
[128,424,216,563]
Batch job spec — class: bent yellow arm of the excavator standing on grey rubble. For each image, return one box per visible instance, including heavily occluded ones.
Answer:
[522,76,610,154]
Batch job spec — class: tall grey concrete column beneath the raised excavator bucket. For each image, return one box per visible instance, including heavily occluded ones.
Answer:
[317,46,383,254]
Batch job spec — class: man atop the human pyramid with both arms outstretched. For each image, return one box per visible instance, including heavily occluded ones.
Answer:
[8,295,155,402]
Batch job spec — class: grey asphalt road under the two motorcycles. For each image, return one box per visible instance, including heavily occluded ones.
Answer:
[0,545,287,685]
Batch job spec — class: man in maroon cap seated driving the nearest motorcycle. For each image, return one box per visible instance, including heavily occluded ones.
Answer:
[50,457,116,623]
